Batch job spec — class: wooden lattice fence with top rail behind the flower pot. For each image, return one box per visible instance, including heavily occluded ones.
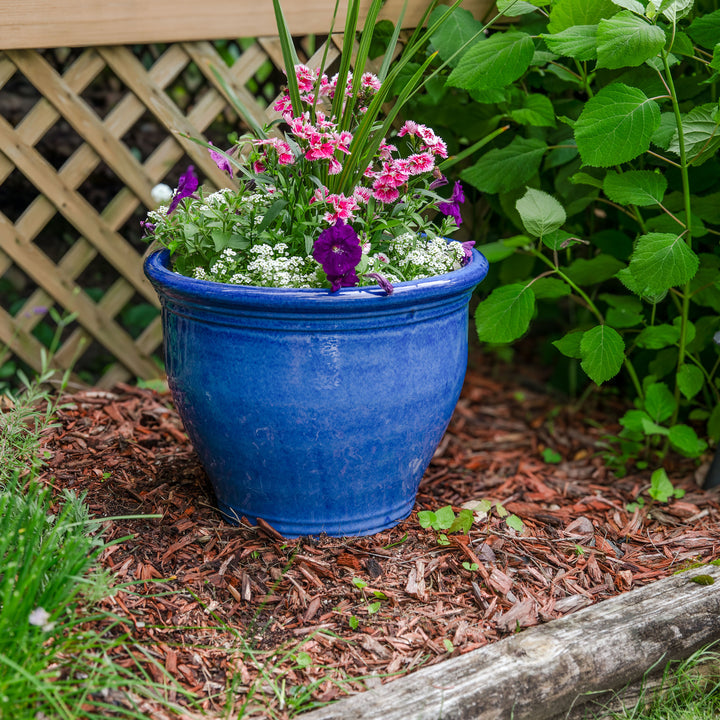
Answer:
[0,0,491,387]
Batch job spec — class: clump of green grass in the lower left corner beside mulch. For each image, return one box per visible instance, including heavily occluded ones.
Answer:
[0,348,202,720]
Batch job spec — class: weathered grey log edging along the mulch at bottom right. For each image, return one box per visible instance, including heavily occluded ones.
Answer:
[300,565,720,720]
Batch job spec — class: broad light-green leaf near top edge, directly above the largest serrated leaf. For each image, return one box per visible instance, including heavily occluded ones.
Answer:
[597,10,665,69]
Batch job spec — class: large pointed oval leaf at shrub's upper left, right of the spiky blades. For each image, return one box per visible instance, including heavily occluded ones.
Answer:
[447,31,535,91]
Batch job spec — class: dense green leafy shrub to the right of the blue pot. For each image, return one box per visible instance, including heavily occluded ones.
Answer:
[413,0,720,469]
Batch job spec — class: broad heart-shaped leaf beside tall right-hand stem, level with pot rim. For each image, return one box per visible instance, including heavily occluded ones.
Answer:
[628,233,700,294]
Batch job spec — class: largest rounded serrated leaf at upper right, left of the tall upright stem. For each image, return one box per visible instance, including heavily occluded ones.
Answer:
[574,83,660,167]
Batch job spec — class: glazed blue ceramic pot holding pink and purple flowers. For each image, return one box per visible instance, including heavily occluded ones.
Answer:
[145,250,488,537]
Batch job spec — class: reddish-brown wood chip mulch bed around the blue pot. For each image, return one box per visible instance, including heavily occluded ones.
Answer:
[38,357,720,717]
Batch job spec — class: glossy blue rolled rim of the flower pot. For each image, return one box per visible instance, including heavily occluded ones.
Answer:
[144,246,488,311]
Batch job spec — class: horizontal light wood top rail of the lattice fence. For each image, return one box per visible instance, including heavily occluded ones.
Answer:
[0,0,494,49]
